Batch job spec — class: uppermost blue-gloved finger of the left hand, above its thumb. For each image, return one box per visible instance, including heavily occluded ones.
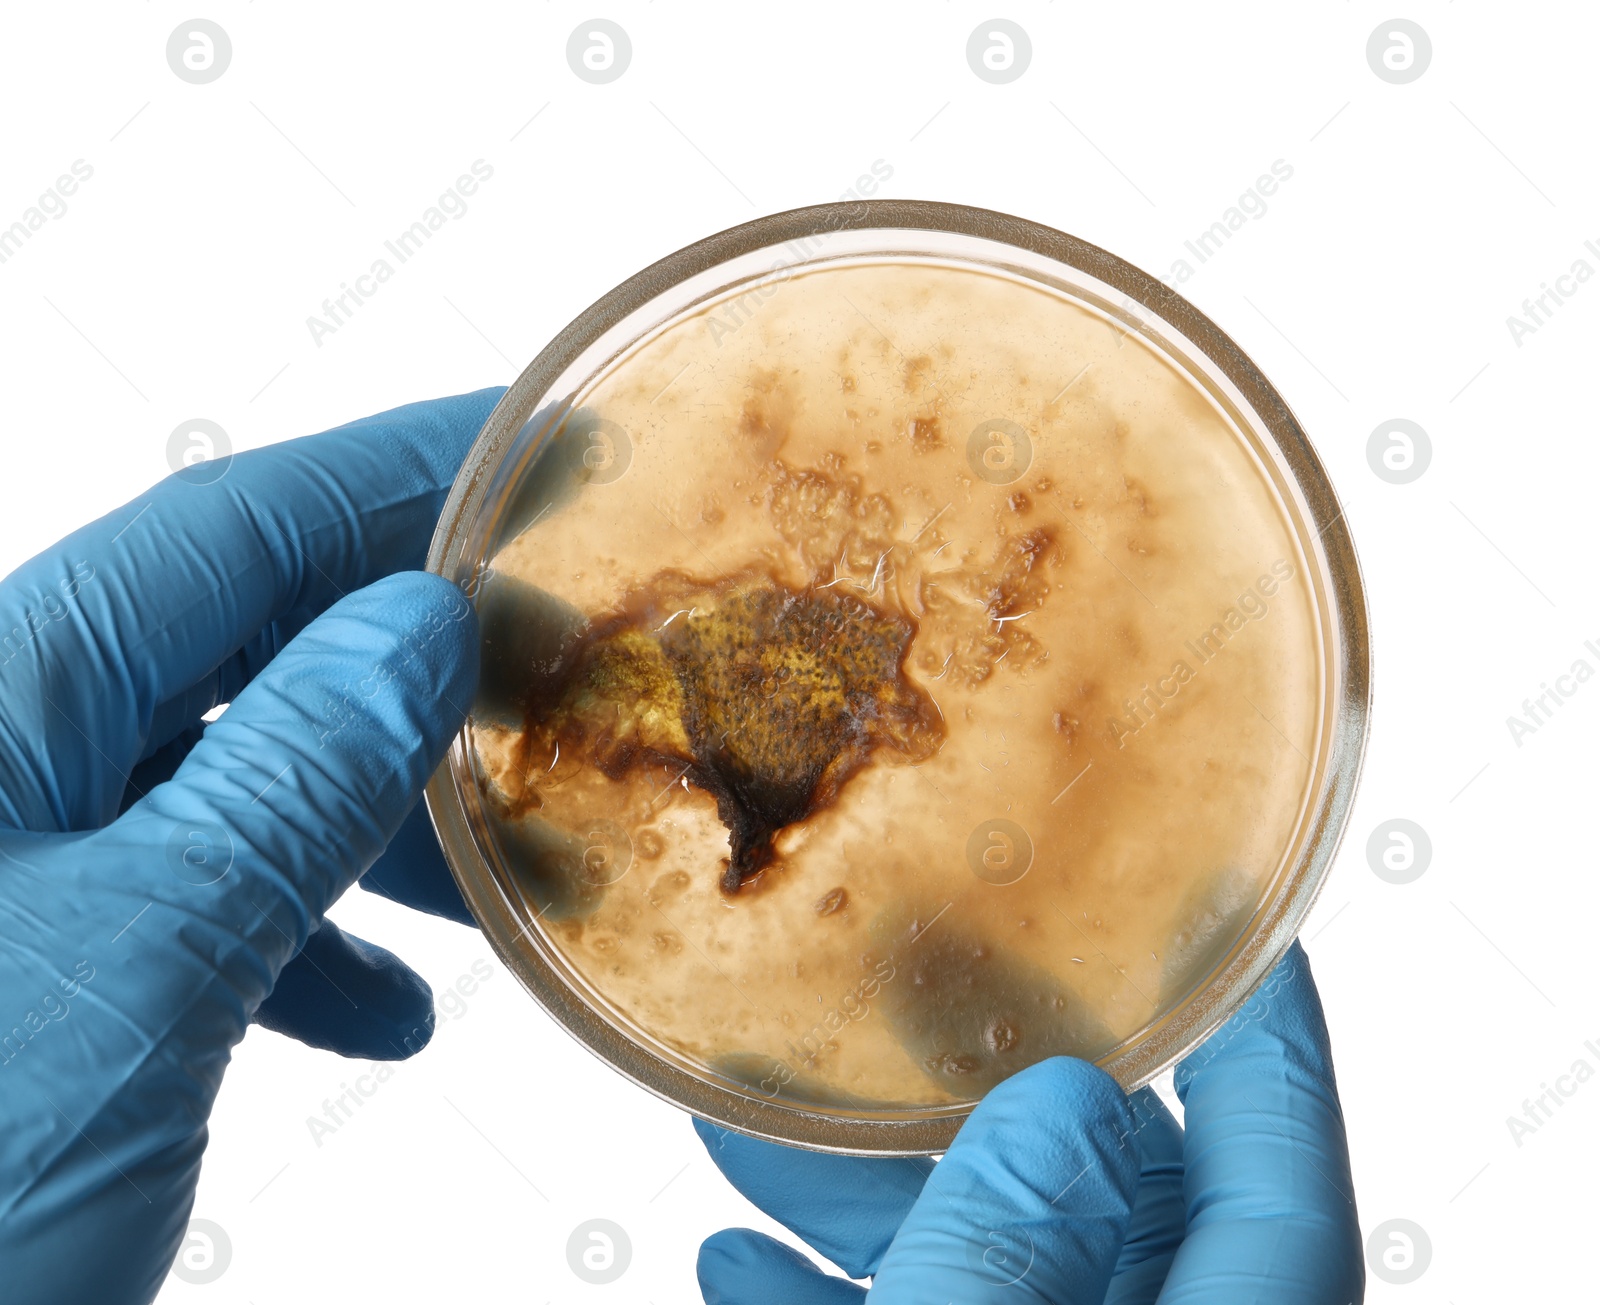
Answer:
[0,390,501,830]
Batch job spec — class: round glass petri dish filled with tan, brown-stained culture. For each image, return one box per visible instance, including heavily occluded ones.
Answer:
[427,200,1370,1155]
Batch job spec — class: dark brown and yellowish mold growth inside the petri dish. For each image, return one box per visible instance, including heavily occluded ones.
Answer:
[526,573,944,892]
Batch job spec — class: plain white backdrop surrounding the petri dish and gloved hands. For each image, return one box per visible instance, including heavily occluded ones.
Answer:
[0,0,1600,1305]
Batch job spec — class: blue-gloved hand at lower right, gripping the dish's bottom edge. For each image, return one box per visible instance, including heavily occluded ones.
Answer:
[696,944,1365,1305]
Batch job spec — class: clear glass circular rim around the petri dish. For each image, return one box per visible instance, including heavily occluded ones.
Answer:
[427,200,1371,1155]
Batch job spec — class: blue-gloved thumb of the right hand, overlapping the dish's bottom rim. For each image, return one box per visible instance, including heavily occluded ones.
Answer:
[870,1057,1139,1305]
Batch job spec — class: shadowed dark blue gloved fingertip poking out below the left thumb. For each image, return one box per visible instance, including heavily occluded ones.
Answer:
[254,920,434,1060]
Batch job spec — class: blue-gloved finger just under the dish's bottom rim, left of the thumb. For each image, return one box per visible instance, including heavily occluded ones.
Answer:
[694,1119,934,1279]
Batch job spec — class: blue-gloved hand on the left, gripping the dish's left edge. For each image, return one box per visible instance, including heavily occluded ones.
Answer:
[0,390,501,1305]
